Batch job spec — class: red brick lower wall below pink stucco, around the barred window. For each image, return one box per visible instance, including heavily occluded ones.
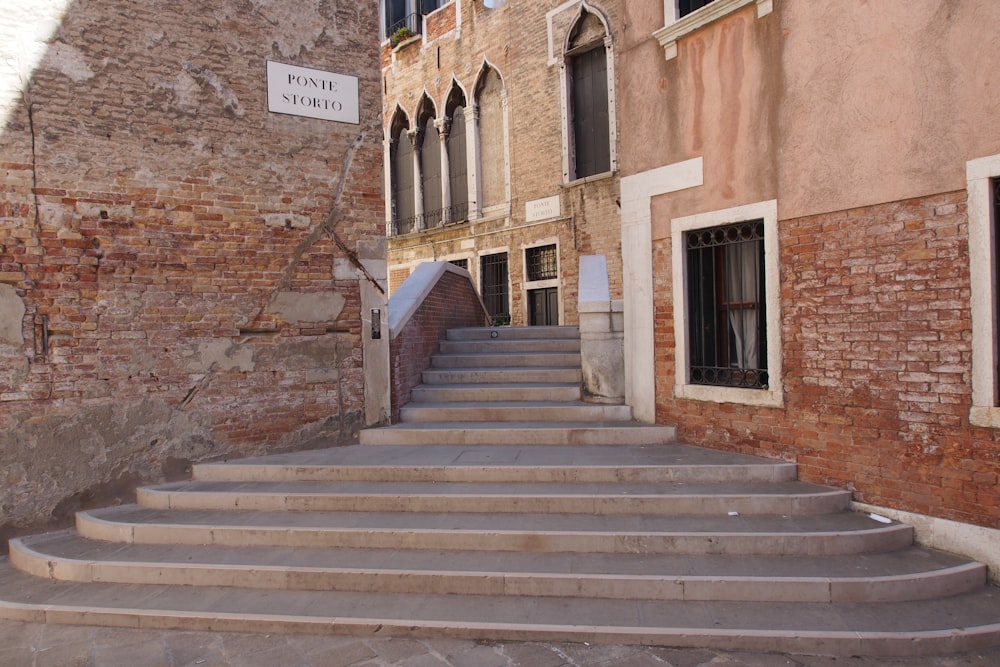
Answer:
[655,191,1000,528]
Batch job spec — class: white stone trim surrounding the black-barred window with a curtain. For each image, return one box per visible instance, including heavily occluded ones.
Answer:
[670,199,785,407]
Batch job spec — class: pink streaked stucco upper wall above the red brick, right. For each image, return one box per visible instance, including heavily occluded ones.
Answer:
[621,0,1000,227]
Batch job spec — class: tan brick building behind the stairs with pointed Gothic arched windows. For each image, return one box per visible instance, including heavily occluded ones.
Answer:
[380,0,623,324]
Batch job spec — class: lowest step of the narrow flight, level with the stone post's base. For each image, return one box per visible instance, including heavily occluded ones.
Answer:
[399,401,632,423]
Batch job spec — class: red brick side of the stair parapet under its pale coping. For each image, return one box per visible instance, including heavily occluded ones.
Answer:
[389,271,488,422]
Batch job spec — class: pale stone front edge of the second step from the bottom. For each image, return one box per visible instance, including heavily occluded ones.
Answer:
[10,539,986,603]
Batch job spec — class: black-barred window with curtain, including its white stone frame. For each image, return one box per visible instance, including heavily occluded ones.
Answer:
[670,200,784,407]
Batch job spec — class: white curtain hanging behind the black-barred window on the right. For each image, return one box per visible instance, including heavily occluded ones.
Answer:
[725,241,759,368]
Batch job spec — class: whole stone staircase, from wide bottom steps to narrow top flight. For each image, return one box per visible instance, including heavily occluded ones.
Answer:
[0,327,1000,656]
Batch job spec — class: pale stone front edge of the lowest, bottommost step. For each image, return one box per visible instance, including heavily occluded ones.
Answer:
[0,588,1000,657]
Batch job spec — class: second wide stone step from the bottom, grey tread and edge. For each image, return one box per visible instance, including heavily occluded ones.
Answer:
[11,531,986,603]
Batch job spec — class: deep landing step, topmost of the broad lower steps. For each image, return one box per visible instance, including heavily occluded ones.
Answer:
[192,443,796,484]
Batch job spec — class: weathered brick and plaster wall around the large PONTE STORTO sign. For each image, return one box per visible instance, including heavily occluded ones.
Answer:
[0,0,385,535]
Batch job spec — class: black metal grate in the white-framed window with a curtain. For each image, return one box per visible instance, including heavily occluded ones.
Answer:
[685,220,768,389]
